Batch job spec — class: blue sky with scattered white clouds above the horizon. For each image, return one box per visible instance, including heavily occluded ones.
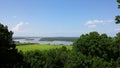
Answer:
[0,0,120,37]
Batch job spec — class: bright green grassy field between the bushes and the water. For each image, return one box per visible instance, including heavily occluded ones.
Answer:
[16,44,72,52]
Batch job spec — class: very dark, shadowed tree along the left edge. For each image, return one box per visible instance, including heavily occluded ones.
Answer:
[0,24,23,68]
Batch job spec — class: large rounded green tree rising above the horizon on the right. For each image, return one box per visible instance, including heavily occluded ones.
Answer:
[73,32,112,60]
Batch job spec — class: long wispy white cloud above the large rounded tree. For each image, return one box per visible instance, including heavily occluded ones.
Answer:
[85,20,113,28]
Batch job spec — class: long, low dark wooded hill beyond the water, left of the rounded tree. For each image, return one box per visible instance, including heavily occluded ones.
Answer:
[39,37,79,42]
